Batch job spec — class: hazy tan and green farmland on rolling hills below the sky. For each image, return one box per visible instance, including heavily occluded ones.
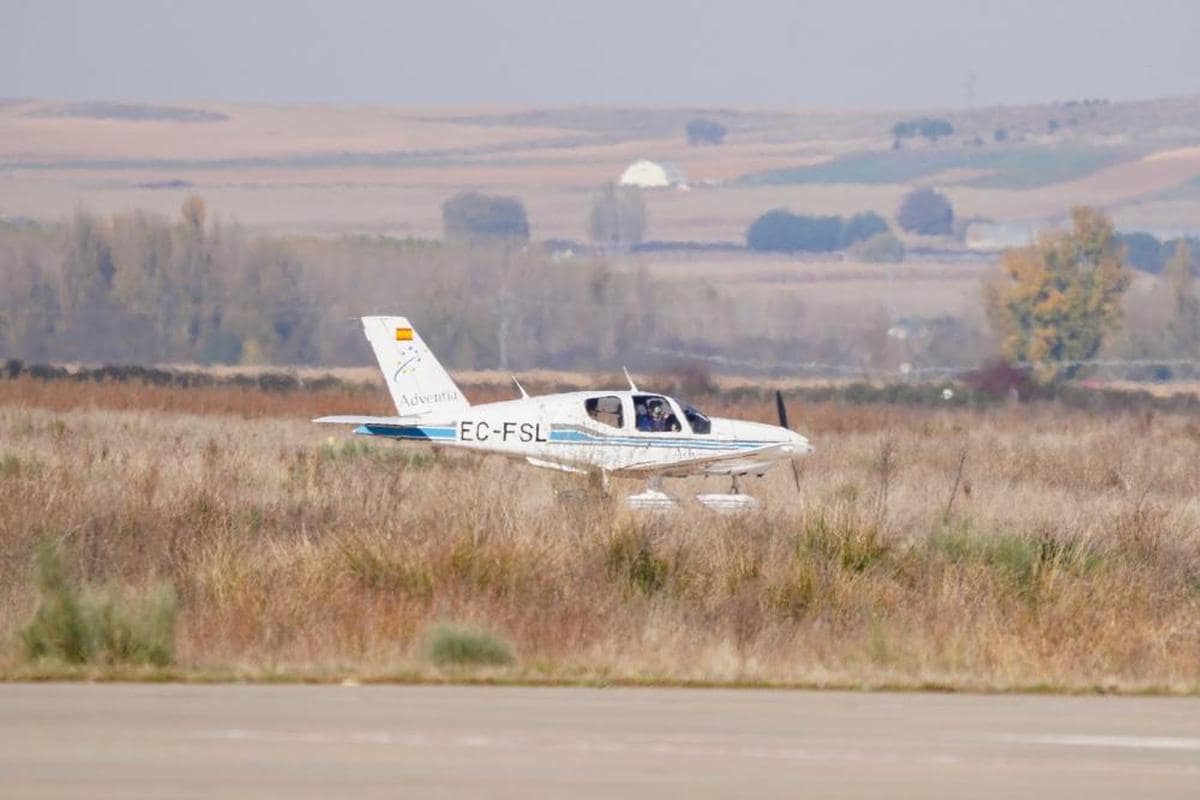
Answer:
[0,97,1200,241]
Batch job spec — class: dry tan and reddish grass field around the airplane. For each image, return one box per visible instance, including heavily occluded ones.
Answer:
[0,378,1200,693]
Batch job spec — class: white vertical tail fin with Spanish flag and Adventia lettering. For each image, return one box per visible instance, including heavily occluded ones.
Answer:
[362,317,470,419]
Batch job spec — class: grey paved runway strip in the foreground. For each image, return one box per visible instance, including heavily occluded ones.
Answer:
[0,684,1200,800]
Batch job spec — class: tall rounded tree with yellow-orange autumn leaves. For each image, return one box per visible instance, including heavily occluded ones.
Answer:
[984,206,1129,378]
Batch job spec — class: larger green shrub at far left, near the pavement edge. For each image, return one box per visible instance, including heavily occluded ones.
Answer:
[20,543,176,667]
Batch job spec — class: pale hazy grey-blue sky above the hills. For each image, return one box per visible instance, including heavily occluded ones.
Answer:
[0,0,1200,108]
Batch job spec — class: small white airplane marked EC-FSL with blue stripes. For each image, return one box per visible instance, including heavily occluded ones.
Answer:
[313,317,812,510]
